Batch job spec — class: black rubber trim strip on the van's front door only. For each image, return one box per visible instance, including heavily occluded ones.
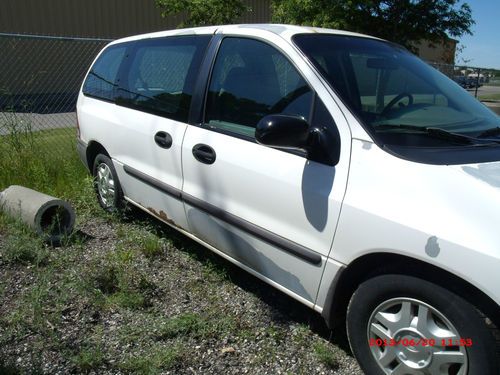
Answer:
[182,193,321,264]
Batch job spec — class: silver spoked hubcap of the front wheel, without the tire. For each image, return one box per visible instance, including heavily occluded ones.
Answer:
[367,298,467,375]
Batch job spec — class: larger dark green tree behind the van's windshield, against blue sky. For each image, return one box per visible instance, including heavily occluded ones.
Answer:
[272,0,474,49]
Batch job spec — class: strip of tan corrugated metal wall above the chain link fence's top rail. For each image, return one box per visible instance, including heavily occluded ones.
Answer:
[0,0,271,38]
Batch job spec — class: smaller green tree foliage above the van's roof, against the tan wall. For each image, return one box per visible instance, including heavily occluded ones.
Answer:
[156,0,250,27]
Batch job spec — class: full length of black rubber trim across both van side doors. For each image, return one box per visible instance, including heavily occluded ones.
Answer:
[123,165,321,265]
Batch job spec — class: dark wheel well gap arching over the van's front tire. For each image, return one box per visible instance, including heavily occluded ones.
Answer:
[322,253,500,330]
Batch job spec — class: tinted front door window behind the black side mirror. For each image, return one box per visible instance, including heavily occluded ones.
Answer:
[205,38,312,137]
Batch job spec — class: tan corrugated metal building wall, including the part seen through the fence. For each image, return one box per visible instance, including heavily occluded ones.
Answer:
[0,0,270,112]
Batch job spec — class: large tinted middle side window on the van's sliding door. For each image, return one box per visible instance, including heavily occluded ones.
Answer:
[118,36,210,122]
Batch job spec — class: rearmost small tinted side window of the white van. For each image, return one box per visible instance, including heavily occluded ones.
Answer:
[83,44,127,100]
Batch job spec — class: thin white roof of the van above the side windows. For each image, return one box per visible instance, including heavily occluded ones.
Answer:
[113,24,377,43]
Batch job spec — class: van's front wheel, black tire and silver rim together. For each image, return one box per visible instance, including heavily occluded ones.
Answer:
[346,275,500,375]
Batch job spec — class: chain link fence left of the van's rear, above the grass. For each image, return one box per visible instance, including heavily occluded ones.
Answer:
[0,33,109,142]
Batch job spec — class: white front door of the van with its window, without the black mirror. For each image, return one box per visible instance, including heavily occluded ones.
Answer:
[182,37,350,306]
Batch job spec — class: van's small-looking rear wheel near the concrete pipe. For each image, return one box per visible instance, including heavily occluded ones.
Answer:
[92,154,125,212]
